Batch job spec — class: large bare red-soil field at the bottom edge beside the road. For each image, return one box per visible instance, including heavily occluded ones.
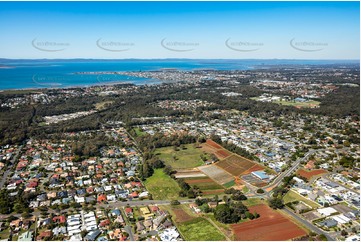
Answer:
[232,204,307,241]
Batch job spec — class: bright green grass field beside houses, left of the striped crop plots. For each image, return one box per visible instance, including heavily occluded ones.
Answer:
[144,169,181,200]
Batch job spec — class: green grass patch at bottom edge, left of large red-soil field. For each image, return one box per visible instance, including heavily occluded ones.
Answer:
[178,218,225,241]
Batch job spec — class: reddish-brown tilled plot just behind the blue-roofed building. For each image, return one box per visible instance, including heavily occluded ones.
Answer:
[216,155,264,176]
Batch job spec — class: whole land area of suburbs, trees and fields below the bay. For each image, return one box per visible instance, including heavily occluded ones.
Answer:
[0,64,360,241]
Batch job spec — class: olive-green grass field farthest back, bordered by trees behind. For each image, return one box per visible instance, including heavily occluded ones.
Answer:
[154,144,209,169]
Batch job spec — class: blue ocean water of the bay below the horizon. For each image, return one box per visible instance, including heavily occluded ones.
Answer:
[0,59,356,90]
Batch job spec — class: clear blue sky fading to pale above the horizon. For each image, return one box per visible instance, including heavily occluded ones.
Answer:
[0,2,360,59]
